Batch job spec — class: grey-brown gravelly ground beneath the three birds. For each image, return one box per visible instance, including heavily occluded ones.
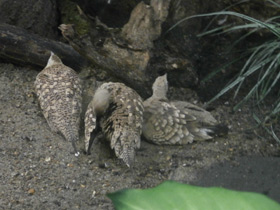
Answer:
[0,64,280,210]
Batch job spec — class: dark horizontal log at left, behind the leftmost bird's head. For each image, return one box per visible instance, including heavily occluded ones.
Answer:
[0,24,86,70]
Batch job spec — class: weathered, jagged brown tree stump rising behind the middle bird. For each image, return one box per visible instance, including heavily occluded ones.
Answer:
[59,0,170,97]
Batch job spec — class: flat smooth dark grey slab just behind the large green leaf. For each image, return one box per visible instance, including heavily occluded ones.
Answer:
[171,157,280,202]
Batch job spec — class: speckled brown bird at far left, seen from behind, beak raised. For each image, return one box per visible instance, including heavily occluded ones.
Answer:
[35,52,82,156]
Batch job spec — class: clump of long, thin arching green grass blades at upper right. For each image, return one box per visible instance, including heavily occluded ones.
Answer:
[166,0,280,143]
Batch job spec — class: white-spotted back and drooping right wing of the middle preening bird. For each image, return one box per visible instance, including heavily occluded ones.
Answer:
[98,83,143,166]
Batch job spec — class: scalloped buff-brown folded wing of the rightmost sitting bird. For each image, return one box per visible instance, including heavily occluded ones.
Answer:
[143,100,196,144]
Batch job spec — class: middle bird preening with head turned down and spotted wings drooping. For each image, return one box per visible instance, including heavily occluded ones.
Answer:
[85,82,144,167]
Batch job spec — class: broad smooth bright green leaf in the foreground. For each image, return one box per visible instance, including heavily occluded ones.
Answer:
[108,181,280,210]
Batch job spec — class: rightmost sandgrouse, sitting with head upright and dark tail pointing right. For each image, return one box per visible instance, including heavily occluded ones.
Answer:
[143,74,227,144]
